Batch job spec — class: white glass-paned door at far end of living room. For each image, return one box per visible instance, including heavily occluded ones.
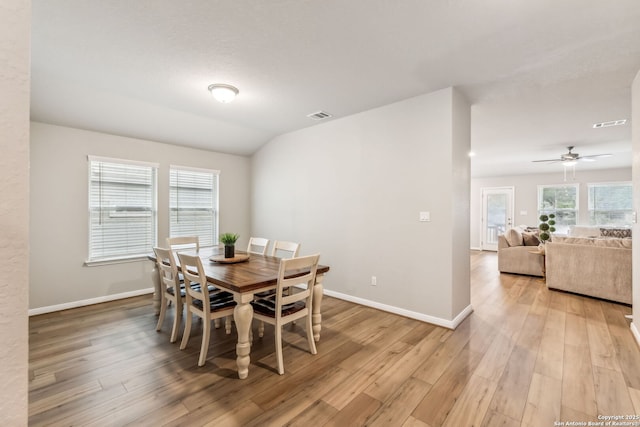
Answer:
[480,187,514,251]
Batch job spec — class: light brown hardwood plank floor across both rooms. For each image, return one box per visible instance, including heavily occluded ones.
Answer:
[29,252,640,427]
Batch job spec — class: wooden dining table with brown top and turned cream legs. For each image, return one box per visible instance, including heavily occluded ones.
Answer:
[149,246,329,379]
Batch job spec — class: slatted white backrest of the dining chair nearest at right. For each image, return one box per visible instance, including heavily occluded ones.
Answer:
[276,255,320,319]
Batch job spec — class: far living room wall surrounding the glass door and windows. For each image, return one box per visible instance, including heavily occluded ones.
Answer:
[471,165,631,249]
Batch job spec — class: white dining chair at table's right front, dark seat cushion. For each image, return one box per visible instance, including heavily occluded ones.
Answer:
[251,255,320,375]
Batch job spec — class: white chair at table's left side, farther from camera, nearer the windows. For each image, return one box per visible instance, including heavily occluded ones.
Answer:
[153,248,185,342]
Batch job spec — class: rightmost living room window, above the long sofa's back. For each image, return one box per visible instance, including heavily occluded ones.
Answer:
[587,182,633,225]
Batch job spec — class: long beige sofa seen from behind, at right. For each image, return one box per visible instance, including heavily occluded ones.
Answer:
[545,229,632,304]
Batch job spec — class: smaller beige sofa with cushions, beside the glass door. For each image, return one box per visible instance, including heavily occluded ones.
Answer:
[498,226,545,277]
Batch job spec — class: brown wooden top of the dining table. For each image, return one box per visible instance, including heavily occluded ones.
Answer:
[156,247,329,293]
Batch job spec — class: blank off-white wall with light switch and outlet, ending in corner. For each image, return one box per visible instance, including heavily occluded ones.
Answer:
[252,88,469,322]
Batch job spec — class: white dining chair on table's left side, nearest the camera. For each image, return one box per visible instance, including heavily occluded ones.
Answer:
[178,253,236,366]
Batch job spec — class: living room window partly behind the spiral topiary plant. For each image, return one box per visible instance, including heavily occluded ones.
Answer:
[538,184,579,233]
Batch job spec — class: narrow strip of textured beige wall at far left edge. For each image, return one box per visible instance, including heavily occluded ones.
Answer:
[0,0,31,426]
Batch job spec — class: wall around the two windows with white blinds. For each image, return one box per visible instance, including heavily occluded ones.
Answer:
[29,123,251,309]
